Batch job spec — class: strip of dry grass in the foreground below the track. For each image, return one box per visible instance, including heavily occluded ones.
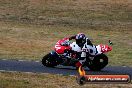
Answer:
[0,72,132,88]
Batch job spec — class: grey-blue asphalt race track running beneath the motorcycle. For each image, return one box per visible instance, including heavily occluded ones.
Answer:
[0,60,132,77]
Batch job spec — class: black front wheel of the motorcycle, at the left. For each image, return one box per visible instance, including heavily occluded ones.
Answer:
[42,53,57,67]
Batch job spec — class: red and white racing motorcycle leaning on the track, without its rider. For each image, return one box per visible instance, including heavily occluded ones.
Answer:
[42,40,112,71]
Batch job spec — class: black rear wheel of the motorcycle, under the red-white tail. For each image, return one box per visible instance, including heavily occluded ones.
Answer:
[87,54,108,71]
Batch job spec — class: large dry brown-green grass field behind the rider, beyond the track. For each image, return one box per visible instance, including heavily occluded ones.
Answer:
[0,0,132,66]
